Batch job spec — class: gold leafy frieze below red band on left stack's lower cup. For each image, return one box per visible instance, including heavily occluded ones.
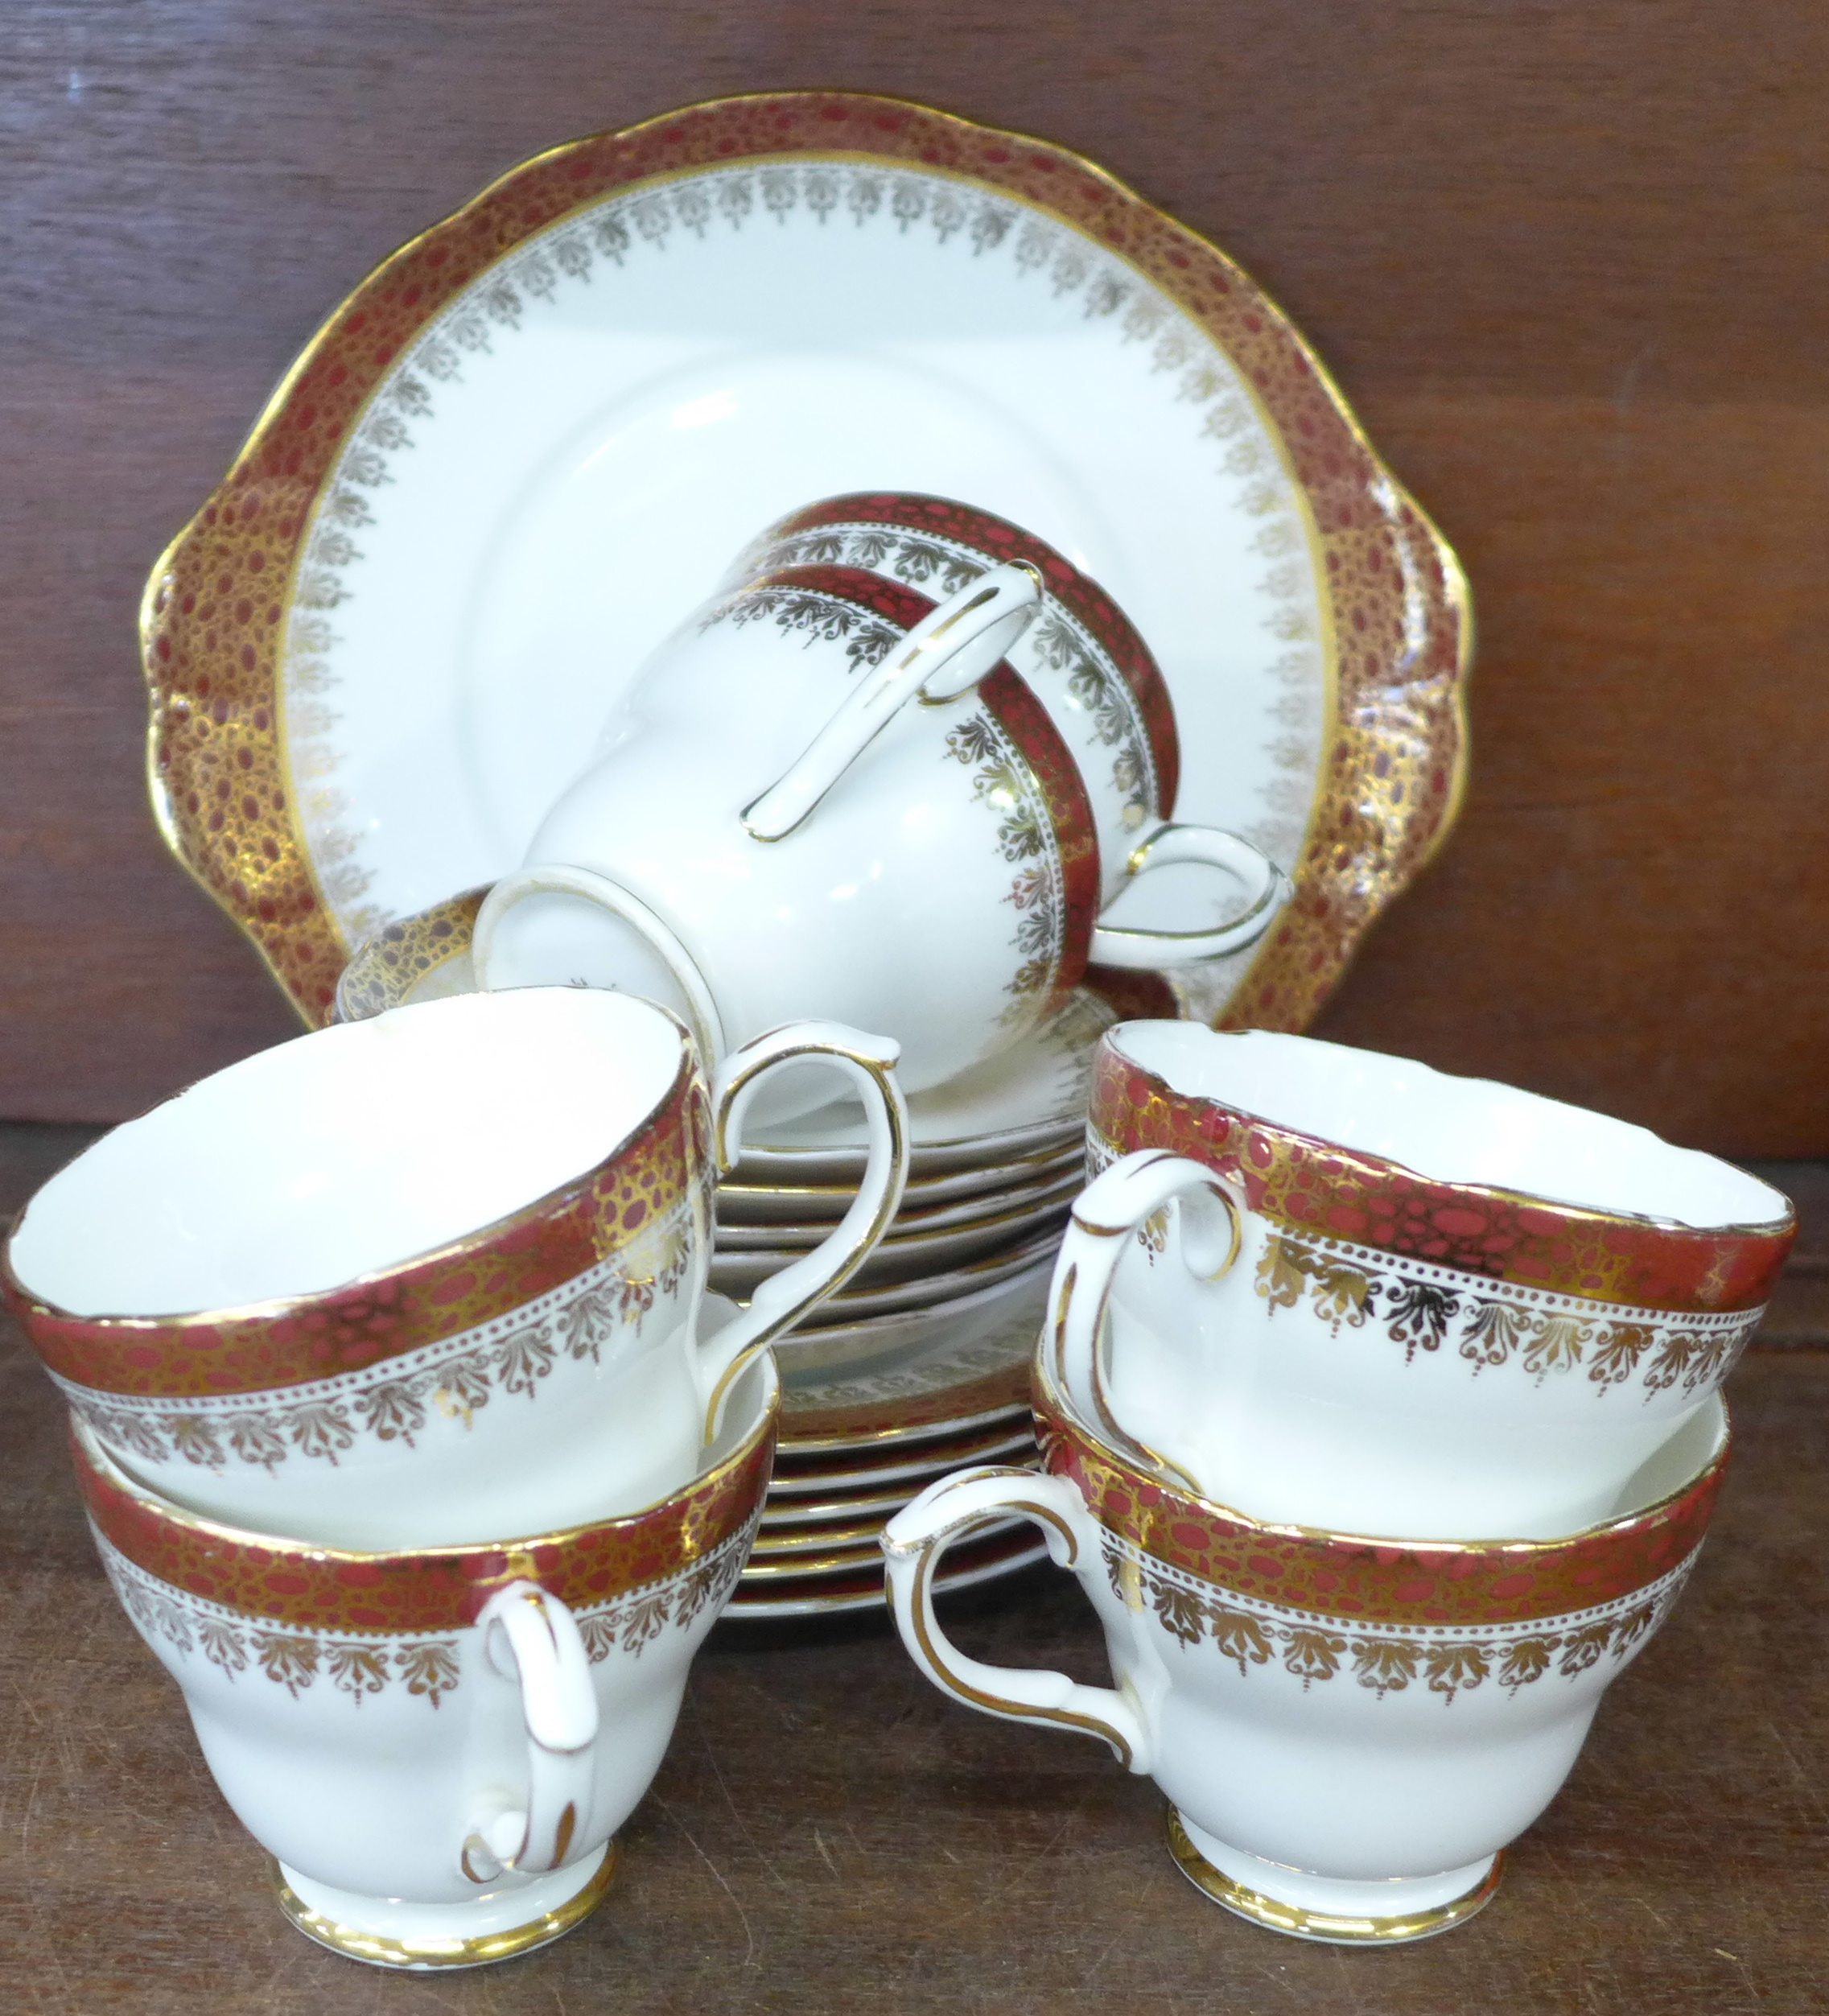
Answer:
[91,1520,754,1708]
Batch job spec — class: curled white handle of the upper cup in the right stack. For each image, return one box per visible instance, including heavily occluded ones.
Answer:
[1044,1147,1250,1492]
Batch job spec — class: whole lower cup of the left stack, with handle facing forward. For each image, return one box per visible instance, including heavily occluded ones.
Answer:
[75,1353,781,1969]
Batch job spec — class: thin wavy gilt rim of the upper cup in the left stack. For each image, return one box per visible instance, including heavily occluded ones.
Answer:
[0,987,698,1338]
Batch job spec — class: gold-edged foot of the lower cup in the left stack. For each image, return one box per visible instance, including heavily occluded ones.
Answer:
[268,1841,617,1973]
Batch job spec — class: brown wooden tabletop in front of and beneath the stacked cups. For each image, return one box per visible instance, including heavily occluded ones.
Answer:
[0,1282,1829,2016]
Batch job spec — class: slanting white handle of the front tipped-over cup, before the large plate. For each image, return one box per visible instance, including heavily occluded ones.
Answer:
[742,563,1043,841]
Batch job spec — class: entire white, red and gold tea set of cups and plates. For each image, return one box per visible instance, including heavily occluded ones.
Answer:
[14,93,1793,1972]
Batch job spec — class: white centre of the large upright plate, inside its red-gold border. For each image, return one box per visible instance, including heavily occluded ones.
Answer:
[284,161,1327,1024]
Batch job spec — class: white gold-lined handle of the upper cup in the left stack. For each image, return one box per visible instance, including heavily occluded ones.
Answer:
[696,1022,908,1448]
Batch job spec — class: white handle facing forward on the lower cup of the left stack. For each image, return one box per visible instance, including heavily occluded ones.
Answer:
[459,1582,599,1883]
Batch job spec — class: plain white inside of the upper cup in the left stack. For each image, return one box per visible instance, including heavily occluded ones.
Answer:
[12,987,684,1317]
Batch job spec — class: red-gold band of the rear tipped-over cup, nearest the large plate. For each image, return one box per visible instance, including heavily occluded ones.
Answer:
[764,492,1182,818]
